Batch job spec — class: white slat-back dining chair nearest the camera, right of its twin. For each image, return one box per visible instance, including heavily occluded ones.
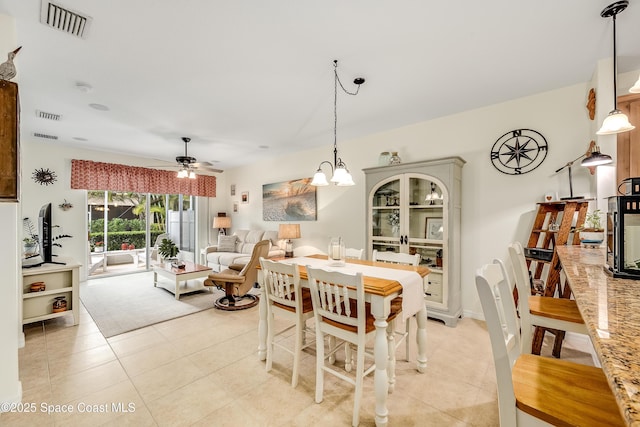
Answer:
[307,266,402,426]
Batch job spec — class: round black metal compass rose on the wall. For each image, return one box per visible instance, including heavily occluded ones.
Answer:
[491,129,549,175]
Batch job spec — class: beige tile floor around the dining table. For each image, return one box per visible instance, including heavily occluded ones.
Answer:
[0,298,588,426]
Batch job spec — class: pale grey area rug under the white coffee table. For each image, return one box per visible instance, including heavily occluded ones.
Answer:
[80,272,224,338]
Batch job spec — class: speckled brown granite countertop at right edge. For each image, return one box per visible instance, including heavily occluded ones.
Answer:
[556,245,640,426]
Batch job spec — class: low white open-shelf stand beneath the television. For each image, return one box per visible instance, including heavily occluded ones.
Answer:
[22,259,80,325]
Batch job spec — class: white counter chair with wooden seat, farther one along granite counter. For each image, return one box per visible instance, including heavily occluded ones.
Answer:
[509,242,588,357]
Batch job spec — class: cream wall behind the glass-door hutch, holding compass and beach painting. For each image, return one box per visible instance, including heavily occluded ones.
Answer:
[224,83,608,317]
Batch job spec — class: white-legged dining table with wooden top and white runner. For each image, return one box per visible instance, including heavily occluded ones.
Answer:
[258,255,430,426]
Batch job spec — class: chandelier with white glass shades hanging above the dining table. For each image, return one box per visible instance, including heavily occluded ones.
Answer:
[311,61,364,187]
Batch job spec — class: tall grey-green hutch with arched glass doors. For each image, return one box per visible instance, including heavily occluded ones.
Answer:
[364,157,465,326]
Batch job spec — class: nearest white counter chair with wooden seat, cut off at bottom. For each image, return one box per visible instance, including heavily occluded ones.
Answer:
[475,261,624,427]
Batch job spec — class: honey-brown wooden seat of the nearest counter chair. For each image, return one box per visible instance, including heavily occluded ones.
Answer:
[511,354,624,426]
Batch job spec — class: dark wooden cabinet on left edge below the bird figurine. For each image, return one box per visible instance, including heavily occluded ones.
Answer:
[0,80,20,202]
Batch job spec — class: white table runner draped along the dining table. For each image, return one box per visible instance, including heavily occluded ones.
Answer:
[281,257,424,321]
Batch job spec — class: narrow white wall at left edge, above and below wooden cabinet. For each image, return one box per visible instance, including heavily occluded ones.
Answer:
[0,14,23,403]
